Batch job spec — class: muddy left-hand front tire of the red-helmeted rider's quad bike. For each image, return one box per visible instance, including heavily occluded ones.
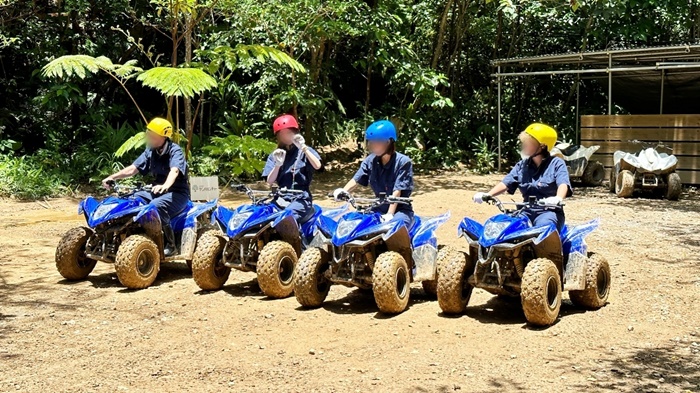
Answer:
[192,231,231,291]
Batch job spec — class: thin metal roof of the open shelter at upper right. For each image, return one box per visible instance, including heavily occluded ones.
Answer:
[491,44,700,67]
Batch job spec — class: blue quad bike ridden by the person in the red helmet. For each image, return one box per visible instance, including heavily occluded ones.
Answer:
[192,185,347,299]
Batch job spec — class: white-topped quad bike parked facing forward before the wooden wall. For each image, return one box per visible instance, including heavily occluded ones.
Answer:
[610,141,683,201]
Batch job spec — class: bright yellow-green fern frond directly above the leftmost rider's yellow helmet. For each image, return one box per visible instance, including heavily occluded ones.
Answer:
[136,67,216,98]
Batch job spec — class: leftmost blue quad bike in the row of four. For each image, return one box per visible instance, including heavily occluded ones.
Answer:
[56,182,216,289]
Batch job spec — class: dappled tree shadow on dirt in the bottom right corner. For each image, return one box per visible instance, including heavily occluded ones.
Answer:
[574,337,700,392]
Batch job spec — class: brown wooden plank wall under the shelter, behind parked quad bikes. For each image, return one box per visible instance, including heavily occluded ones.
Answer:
[581,115,700,184]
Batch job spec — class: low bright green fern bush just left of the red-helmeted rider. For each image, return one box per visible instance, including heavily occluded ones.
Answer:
[202,135,276,178]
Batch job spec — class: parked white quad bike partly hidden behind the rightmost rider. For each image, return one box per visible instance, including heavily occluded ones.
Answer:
[551,142,605,187]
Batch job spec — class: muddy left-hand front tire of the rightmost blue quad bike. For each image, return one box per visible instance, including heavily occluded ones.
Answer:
[437,247,474,314]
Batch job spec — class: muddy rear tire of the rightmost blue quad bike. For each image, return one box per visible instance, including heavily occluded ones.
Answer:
[569,254,612,310]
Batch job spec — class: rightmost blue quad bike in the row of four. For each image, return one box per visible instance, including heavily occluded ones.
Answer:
[437,197,611,326]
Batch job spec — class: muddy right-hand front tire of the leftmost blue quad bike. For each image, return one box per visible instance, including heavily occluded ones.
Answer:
[114,235,160,289]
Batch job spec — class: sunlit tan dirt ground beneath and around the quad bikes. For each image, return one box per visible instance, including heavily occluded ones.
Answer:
[0,173,700,392]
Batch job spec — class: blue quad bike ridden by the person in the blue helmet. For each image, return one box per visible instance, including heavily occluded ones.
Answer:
[294,191,450,314]
